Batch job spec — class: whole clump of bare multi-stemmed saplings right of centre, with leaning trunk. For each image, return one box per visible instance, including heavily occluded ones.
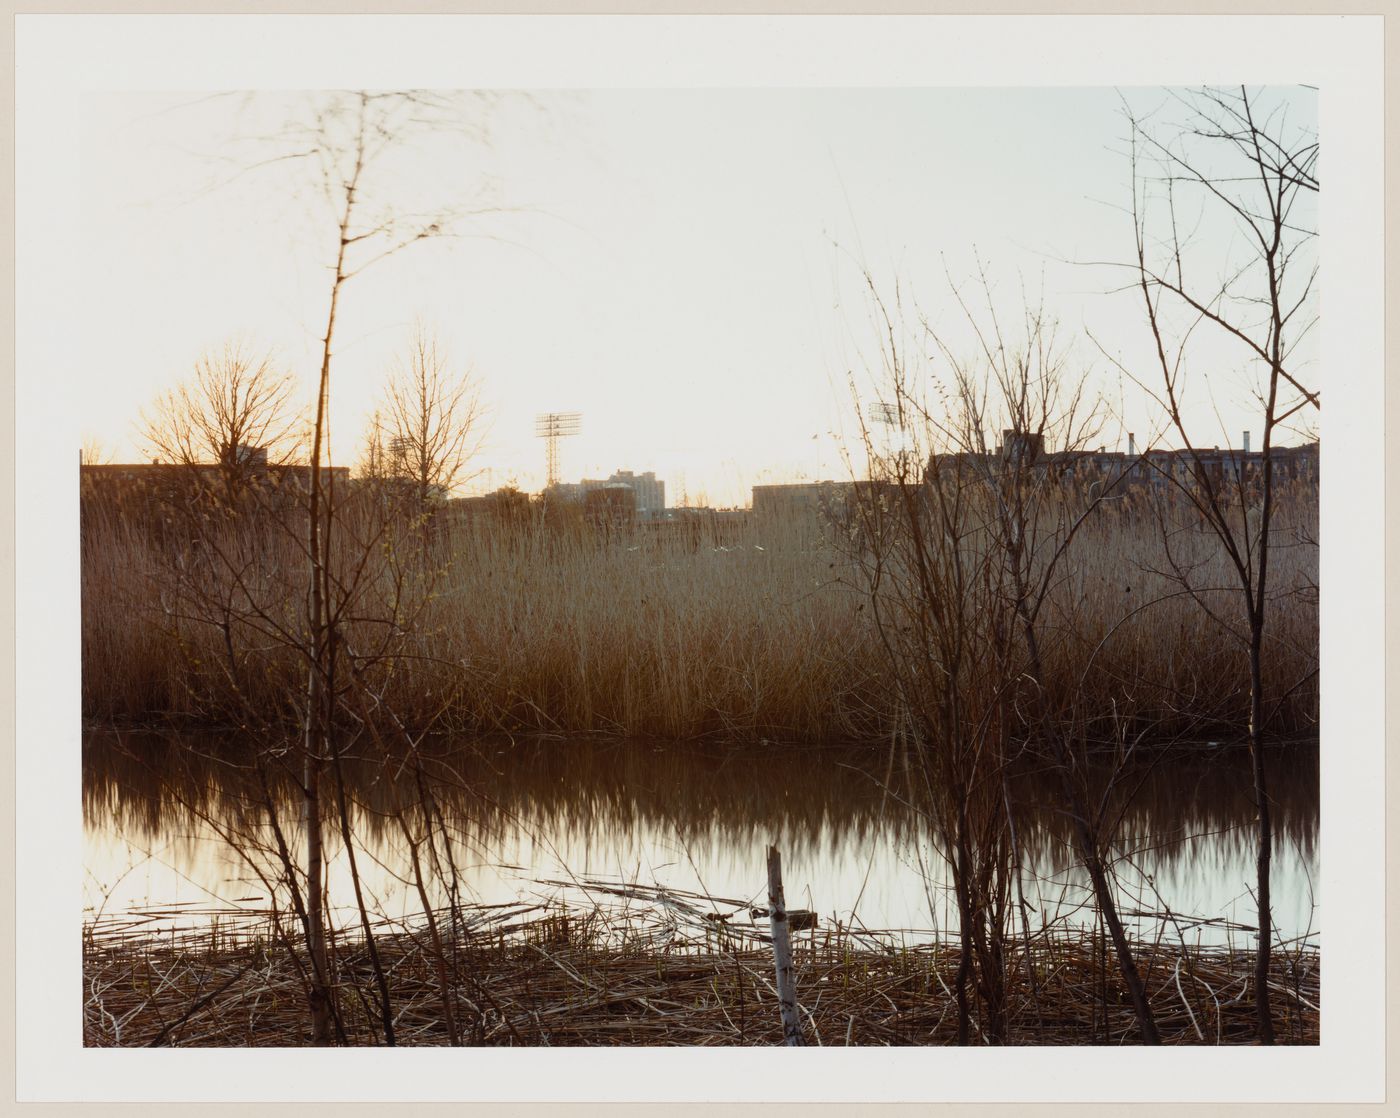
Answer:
[855,274,1158,1044]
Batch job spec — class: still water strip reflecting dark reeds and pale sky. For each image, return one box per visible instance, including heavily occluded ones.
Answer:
[83,732,1320,946]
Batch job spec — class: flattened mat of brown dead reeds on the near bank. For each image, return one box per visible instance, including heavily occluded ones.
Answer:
[83,903,1320,1047]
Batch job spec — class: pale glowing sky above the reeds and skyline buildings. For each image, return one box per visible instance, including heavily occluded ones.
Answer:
[76,87,1316,505]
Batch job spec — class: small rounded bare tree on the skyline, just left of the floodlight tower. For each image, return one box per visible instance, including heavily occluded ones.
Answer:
[371,325,482,512]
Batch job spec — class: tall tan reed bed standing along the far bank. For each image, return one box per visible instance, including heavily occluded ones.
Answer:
[83,491,1317,743]
